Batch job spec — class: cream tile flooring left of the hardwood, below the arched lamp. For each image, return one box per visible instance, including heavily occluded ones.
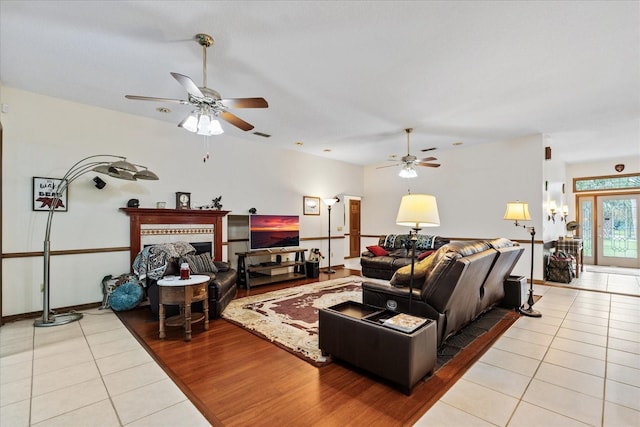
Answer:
[0,309,209,427]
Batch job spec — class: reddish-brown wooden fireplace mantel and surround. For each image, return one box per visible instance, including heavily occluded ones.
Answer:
[120,208,229,265]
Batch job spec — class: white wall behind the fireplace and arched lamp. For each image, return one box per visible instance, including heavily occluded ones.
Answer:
[0,86,363,316]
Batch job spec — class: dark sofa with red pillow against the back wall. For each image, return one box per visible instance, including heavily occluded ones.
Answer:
[360,234,449,280]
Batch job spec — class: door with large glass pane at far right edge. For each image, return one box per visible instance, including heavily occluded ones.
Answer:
[596,194,640,268]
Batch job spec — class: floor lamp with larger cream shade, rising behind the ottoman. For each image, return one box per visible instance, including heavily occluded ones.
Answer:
[396,194,440,314]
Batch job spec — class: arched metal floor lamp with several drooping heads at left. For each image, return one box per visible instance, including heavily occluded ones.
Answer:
[34,154,158,327]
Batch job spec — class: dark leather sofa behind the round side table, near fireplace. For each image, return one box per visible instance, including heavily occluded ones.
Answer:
[140,247,238,320]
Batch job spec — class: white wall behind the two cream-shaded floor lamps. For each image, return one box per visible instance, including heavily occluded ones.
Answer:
[362,135,546,280]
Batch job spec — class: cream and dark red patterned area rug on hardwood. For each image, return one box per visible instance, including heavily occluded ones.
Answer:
[222,276,371,366]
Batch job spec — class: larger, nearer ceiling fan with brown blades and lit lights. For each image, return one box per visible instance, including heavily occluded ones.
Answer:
[125,33,269,136]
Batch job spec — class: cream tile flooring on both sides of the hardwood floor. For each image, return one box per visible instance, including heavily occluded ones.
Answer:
[0,267,640,427]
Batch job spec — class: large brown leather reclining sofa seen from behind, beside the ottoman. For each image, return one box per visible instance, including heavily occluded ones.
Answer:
[362,238,524,346]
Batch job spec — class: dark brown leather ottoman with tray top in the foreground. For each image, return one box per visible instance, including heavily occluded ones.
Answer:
[318,301,437,394]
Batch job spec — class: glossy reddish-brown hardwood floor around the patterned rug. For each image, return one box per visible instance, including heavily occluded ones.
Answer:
[119,268,511,426]
